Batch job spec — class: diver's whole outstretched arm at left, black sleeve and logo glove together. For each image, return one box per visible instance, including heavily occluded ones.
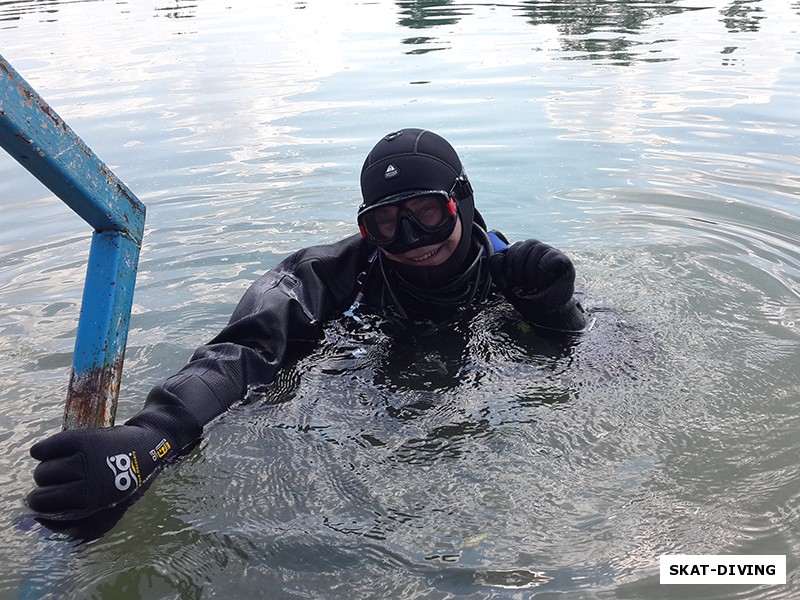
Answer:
[27,236,367,521]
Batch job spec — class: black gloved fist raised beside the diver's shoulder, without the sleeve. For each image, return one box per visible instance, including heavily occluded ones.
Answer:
[489,240,575,310]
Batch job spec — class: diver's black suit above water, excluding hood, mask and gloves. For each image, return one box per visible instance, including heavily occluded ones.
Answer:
[134,224,585,439]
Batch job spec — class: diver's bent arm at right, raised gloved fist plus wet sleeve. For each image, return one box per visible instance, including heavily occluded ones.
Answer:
[489,240,587,333]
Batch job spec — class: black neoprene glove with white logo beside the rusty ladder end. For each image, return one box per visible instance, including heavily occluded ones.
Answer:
[27,407,200,520]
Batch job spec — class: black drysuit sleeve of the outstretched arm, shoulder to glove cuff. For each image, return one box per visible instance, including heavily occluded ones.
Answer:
[140,236,368,427]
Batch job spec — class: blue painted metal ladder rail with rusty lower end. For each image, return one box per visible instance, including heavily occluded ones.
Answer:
[0,56,145,429]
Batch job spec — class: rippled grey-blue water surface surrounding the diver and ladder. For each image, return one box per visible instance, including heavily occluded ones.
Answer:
[0,0,800,600]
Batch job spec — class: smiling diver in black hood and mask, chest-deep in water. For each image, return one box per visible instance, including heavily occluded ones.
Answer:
[26,129,587,522]
